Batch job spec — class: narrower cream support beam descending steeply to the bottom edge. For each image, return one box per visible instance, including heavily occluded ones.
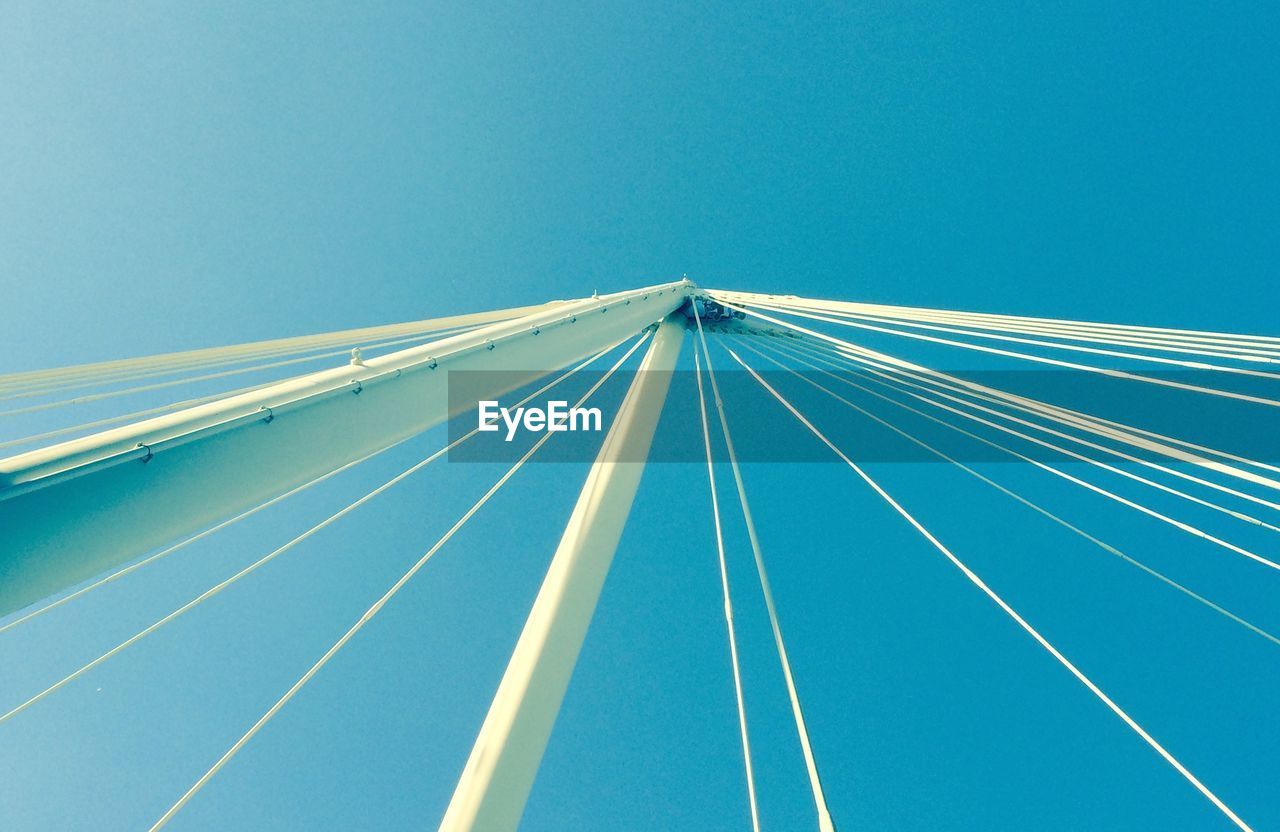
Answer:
[440,316,685,832]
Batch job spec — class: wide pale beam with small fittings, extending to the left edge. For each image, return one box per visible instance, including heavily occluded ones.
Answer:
[0,280,694,616]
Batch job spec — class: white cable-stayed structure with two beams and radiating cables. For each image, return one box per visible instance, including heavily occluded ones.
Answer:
[0,280,1280,832]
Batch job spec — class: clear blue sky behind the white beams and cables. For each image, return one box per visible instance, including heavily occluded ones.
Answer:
[0,1,1280,831]
